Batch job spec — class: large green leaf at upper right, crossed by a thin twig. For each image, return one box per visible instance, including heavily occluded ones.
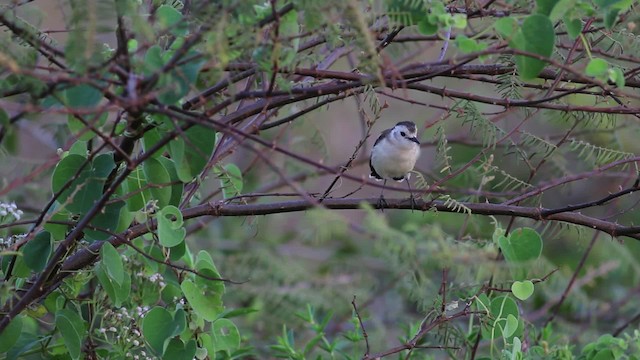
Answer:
[509,14,555,80]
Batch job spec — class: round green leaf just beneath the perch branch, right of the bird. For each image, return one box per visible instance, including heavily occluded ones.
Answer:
[498,228,542,263]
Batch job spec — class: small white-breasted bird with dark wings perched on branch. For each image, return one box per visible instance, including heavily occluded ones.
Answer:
[369,121,420,208]
